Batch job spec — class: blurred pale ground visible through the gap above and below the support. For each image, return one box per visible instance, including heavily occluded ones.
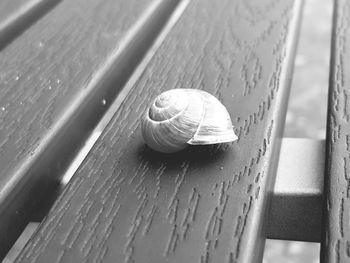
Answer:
[263,0,333,263]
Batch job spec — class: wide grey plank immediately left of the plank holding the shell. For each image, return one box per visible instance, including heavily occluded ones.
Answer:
[0,0,178,258]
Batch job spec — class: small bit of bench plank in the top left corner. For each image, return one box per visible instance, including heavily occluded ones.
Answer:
[0,0,61,49]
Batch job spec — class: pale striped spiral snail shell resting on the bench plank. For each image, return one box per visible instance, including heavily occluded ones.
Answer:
[141,89,237,153]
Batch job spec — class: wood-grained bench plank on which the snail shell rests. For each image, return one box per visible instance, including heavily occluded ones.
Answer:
[17,0,301,262]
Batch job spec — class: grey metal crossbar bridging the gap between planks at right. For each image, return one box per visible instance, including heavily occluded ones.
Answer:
[268,138,325,242]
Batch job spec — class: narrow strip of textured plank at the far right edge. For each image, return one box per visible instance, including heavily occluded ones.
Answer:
[321,0,350,263]
